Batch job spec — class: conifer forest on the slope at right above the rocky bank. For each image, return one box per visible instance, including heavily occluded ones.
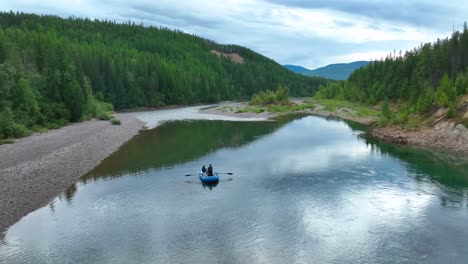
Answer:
[315,23,468,124]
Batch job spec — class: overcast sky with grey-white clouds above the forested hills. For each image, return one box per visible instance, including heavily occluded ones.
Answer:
[0,0,468,69]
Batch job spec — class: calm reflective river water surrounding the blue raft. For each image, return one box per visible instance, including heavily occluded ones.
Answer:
[0,116,468,264]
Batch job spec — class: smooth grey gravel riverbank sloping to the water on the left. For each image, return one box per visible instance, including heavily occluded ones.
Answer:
[0,114,144,234]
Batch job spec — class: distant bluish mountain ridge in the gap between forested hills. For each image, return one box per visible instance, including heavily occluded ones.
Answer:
[284,61,369,80]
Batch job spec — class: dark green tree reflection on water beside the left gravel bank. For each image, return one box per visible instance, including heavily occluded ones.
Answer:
[81,115,302,183]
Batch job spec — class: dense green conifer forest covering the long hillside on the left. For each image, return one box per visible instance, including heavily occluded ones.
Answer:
[0,12,328,139]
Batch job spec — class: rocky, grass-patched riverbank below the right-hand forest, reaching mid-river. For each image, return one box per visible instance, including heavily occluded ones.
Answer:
[202,99,468,155]
